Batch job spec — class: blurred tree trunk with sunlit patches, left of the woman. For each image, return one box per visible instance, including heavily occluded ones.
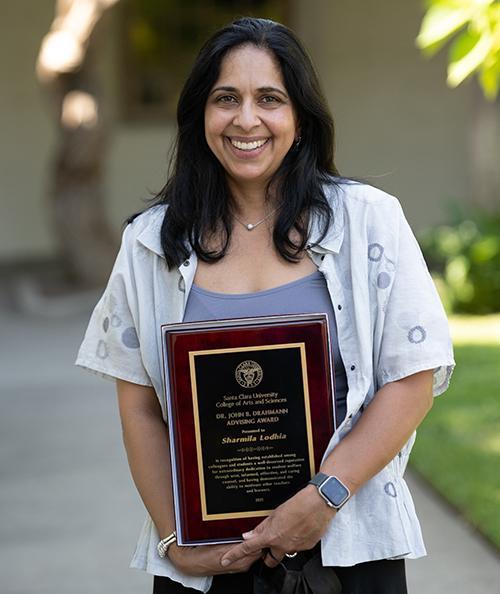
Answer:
[37,0,118,287]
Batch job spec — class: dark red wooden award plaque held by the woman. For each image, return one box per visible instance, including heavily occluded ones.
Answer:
[162,314,335,545]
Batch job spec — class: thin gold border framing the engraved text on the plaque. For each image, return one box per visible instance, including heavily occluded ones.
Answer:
[189,342,316,521]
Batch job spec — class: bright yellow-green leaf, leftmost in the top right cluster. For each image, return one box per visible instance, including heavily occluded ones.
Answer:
[416,4,471,54]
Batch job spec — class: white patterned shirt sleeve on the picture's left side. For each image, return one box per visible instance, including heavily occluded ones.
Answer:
[75,224,152,386]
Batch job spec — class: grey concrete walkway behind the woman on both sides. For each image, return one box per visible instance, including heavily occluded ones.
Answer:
[0,304,500,594]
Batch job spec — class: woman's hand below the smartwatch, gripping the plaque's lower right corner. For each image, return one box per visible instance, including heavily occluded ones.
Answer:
[221,485,336,567]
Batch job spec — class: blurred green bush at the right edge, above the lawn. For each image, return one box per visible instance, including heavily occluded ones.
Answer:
[419,206,500,314]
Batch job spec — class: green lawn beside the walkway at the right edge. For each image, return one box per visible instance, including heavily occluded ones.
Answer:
[410,338,500,548]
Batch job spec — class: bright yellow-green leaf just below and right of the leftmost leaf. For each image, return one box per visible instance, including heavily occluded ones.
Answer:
[447,31,492,87]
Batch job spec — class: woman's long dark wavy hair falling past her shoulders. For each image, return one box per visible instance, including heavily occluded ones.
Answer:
[135,17,338,269]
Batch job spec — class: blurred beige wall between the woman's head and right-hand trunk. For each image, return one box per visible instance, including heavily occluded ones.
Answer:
[294,0,475,228]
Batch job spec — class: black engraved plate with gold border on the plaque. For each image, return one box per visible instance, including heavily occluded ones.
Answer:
[190,343,314,520]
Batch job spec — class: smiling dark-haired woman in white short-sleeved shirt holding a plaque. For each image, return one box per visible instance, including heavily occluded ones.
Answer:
[77,18,453,594]
